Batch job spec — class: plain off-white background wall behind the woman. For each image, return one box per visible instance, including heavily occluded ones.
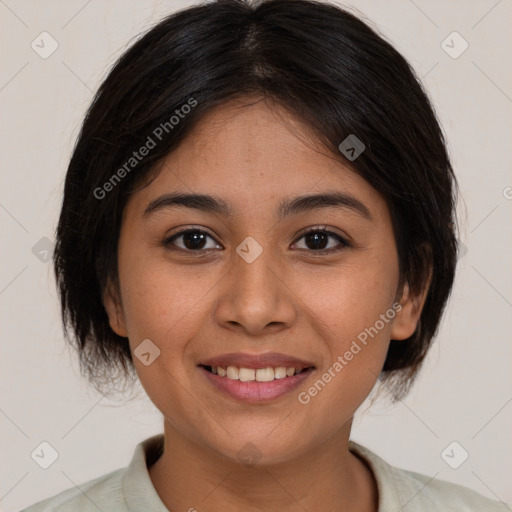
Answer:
[0,0,512,511]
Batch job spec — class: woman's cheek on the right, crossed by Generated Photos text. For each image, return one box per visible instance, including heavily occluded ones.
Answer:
[296,258,400,404]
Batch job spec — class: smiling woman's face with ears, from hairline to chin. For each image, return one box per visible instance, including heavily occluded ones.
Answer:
[105,95,423,463]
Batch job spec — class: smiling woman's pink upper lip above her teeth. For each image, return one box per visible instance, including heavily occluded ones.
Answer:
[200,352,314,369]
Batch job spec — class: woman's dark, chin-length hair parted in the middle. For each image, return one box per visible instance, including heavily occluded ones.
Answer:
[54,0,458,400]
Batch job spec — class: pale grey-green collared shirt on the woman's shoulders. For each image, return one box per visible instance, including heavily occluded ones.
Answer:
[22,434,512,512]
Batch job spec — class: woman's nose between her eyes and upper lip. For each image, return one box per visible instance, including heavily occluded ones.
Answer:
[216,240,297,336]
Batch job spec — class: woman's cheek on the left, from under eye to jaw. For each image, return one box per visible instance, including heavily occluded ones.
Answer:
[119,252,218,429]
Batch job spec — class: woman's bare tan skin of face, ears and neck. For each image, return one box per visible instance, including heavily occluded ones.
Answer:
[104,98,426,512]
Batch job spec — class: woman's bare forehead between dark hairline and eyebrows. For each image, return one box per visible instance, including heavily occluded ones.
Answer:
[126,99,386,221]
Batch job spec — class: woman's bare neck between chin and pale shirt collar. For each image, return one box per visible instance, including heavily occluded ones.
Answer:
[149,422,378,512]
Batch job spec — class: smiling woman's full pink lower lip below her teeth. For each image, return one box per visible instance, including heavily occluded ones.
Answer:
[199,366,314,403]
